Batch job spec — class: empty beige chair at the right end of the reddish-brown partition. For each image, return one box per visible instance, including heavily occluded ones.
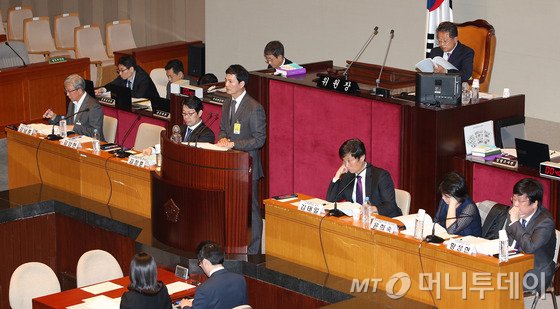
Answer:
[74,25,117,86]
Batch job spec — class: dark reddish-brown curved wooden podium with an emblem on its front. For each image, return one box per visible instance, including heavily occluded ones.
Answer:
[151,131,252,253]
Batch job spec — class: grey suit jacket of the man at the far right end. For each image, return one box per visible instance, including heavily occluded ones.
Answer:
[506,206,556,289]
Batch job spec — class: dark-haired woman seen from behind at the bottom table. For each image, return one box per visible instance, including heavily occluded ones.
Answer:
[121,252,171,309]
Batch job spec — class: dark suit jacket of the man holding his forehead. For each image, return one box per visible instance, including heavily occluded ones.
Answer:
[327,163,402,218]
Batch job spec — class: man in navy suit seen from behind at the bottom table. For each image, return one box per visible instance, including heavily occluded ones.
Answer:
[179,241,248,309]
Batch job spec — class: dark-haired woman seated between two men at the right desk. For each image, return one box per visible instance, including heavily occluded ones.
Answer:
[436,172,482,237]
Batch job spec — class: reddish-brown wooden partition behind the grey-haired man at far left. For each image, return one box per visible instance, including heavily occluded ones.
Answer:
[0,58,90,137]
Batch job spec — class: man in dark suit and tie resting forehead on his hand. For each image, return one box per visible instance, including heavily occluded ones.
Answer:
[327,138,402,217]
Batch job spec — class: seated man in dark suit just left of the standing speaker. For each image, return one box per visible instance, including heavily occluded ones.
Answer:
[142,96,215,156]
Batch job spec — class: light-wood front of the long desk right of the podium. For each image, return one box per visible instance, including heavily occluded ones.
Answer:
[264,194,533,308]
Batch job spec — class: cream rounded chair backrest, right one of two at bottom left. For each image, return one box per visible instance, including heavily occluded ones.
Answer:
[76,249,123,288]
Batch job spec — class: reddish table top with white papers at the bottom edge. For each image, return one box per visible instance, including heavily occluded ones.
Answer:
[33,268,196,309]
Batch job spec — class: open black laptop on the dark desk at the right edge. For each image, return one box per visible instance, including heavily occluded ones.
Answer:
[515,138,560,169]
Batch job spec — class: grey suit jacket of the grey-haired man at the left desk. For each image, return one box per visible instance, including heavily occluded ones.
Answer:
[49,94,105,141]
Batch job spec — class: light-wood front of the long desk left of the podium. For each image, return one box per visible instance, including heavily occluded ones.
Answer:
[6,129,155,218]
